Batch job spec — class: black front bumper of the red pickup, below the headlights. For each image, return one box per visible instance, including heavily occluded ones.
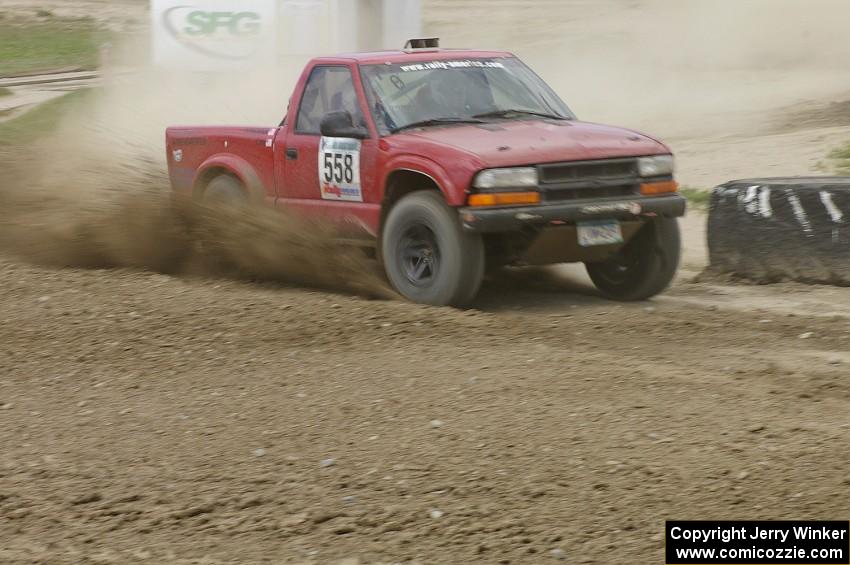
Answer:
[459,194,687,233]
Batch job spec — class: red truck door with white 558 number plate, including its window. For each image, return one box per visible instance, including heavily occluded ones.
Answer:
[276,64,380,235]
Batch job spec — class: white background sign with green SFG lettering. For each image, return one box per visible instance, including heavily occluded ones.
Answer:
[151,0,278,71]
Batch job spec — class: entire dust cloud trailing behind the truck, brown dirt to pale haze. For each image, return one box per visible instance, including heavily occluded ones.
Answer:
[0,31,391,298]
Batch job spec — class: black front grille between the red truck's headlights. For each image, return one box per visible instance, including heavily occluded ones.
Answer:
[538,159,640,202]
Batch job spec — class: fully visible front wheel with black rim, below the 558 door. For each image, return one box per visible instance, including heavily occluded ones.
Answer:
[381,191,484,307]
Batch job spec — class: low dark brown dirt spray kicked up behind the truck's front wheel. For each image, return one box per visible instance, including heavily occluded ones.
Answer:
[0,160,392,298]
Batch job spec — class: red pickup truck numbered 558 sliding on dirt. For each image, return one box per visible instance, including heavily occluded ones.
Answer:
[166,40,685,306]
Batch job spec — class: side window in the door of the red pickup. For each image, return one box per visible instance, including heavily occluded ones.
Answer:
[295,67,366,135]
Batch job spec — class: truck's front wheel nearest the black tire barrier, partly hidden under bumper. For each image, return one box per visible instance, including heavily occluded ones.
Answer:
[585,218,681,301]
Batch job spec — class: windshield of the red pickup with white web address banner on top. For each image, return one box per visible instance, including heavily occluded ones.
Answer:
[362,57,575,134]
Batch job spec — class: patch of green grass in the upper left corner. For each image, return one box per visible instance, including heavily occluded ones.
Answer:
[0,18,107,77]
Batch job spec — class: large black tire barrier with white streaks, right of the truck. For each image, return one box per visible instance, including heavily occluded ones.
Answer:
[708,177,850,286]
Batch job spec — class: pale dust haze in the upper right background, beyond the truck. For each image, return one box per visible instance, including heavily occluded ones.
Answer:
[426,0,850,140]
